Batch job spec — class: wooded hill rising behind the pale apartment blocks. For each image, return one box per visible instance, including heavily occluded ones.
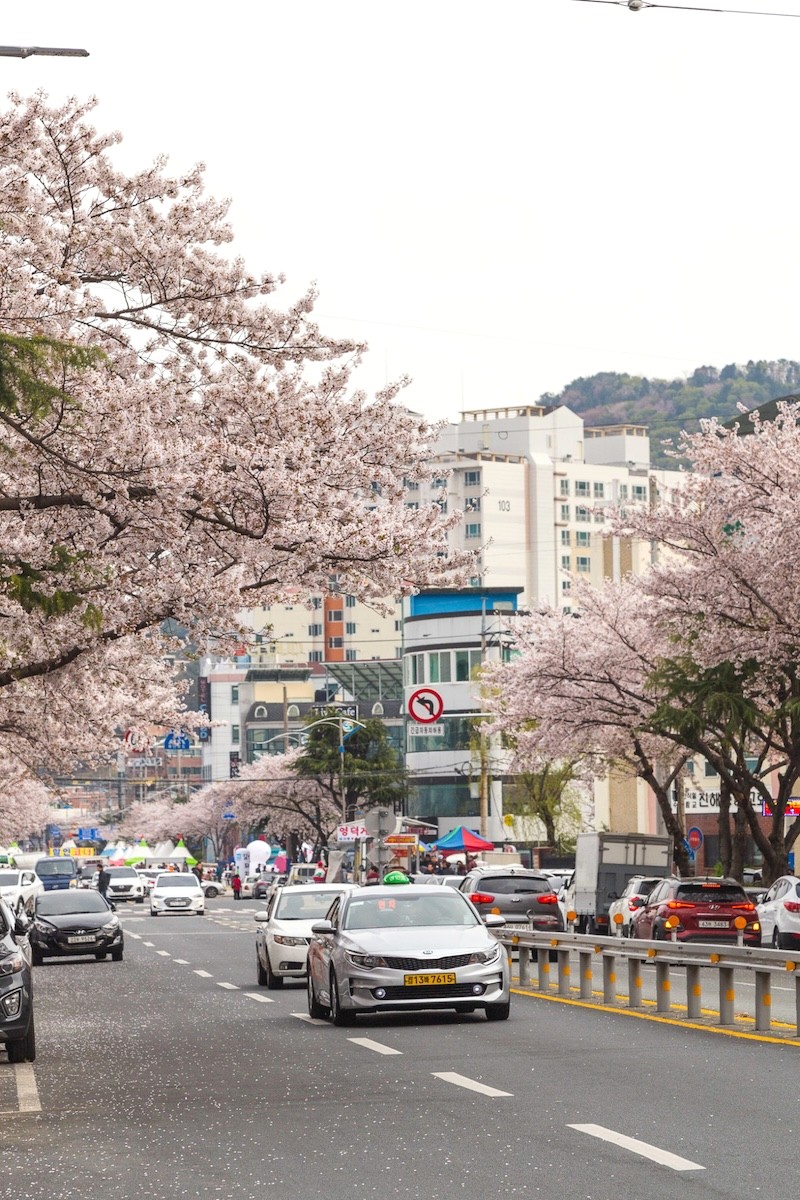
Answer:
[540,359,800,468]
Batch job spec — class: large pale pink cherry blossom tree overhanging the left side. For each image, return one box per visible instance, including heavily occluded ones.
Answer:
[0,95,468,787]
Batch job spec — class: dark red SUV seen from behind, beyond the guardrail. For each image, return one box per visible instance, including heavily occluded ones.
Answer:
[631,876,762,946]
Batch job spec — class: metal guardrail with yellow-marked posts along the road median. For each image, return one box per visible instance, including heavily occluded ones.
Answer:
[497,929,800,1037]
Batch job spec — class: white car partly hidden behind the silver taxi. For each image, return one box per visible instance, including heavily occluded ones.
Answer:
[255,883,354,988]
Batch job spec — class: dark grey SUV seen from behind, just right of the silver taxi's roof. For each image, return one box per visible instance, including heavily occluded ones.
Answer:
[459,866,564,934]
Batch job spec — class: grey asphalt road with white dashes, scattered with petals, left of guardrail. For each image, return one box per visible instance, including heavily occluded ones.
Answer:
[0,899,800,1200]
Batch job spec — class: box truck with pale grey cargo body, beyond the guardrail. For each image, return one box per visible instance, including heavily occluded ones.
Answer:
[567,833,673,934]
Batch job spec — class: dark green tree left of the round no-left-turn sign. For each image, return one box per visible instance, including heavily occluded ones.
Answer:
[293,709,405,821]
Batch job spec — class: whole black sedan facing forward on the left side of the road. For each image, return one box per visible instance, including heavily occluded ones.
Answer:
[30,888,124,966]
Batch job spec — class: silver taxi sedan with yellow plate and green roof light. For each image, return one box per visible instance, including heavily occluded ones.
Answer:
[307,883,511,1025]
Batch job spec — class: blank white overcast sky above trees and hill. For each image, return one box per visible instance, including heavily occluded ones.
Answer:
[10,0,800,419]
